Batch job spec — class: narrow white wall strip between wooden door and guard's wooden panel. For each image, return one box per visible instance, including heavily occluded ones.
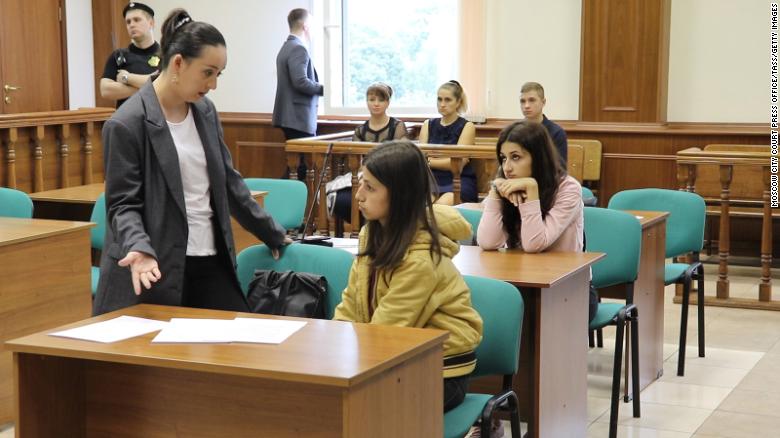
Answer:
[65,0,95,109]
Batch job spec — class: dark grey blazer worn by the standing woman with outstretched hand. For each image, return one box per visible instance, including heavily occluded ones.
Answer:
[93,81,284,315]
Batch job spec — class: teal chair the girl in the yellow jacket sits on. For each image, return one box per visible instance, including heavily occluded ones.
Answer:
[444,275,524,438]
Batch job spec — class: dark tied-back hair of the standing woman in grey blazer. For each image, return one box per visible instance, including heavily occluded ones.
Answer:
[160,8,227,70]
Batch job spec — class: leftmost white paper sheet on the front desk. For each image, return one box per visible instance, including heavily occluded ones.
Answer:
[49,315,168,343]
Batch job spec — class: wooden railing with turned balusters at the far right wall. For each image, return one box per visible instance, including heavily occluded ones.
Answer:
[677,145,780,310]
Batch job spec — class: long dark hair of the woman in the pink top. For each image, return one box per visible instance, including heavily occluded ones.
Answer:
[496,120,566,248]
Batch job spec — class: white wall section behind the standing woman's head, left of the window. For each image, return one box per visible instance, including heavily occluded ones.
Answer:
[146,0,312,113]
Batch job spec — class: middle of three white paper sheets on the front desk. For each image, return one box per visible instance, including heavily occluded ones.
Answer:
[152,318,234,344]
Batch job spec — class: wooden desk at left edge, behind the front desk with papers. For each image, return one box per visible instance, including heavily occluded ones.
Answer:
[0,218,92,424]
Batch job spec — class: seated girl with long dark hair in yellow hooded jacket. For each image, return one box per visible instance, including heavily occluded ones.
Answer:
[334,141,482,412]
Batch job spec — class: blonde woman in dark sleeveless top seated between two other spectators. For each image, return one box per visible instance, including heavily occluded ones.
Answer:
[420,80,478,205]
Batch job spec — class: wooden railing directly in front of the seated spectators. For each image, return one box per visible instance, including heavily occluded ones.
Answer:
[285,132,496,236]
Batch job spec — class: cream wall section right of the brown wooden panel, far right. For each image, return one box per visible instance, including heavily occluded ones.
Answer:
[667,0,770,123]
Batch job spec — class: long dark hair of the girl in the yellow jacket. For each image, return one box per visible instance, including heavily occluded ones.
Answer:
[360,140,441,281]
